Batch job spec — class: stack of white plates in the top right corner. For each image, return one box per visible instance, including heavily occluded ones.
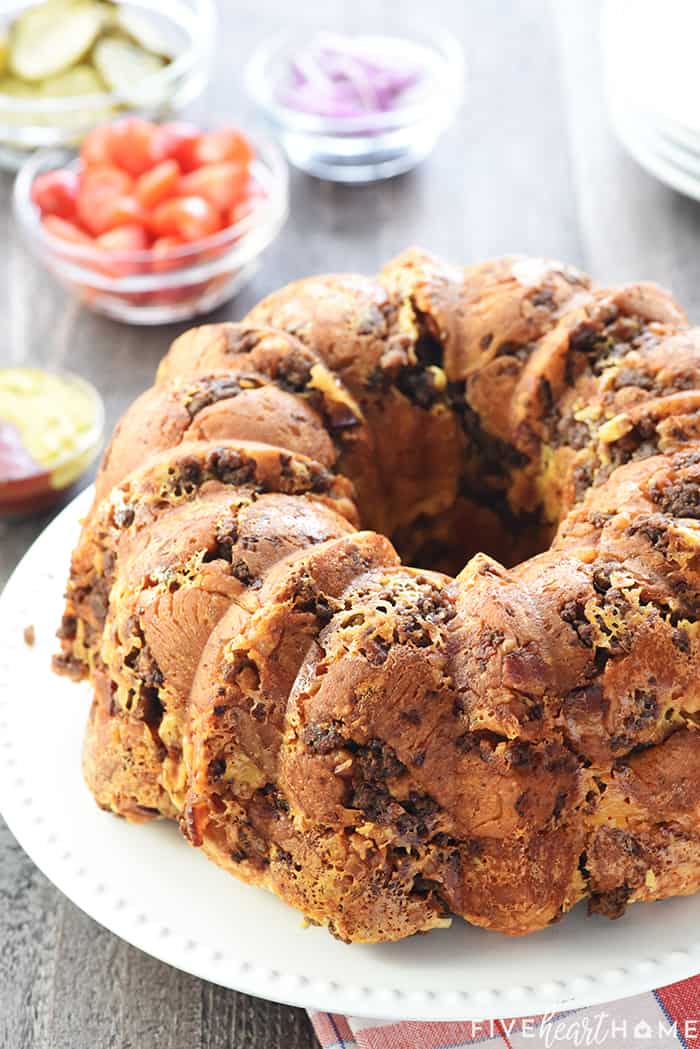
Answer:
[602,0,700,200]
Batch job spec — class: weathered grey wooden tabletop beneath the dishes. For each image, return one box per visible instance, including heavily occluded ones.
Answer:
[0,0,700,1049]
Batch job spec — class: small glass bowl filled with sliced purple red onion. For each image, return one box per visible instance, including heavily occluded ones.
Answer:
[246,26,465,183]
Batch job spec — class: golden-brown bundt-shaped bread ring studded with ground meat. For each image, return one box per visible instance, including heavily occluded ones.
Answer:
[56,252,700,941]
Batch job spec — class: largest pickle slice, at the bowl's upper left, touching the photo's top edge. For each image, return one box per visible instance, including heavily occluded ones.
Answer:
[9,0,104,82]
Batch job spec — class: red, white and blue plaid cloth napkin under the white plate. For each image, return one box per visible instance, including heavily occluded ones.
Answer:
[310,976,700,1049]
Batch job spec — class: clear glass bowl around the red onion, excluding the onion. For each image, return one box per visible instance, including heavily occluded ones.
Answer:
[246,20,465,183]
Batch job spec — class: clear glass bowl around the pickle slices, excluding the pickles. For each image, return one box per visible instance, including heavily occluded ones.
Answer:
[0,0,216,170]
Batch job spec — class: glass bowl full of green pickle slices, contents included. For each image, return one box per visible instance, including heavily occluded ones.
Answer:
[0,0,216,168]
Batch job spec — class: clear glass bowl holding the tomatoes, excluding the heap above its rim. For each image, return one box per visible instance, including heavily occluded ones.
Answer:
[14,132,289,324]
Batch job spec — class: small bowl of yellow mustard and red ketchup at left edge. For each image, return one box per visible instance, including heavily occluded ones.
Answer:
[0,367,104,515]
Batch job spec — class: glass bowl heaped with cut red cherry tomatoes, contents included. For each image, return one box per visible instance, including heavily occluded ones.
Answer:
[14,116,289,324]
